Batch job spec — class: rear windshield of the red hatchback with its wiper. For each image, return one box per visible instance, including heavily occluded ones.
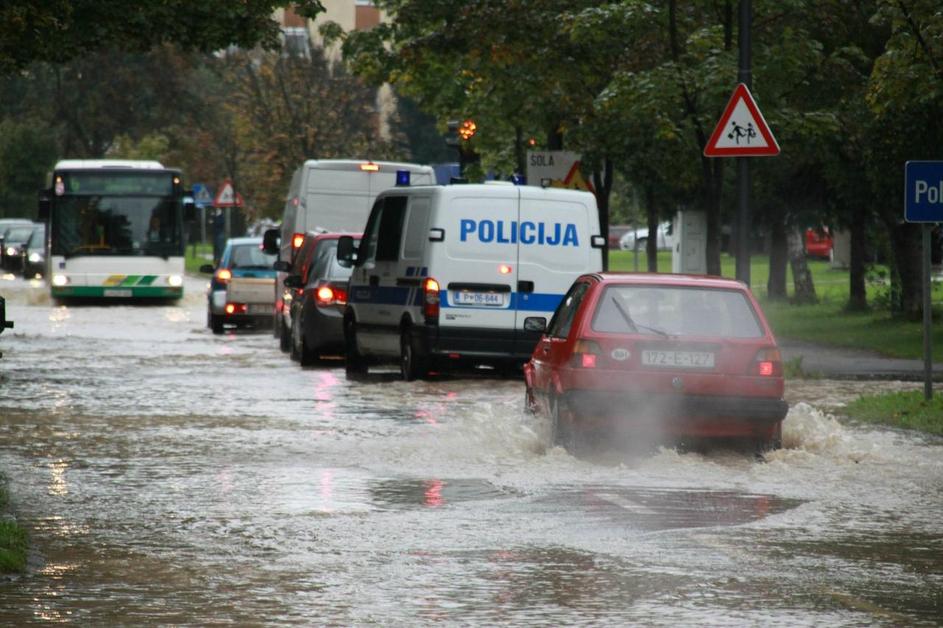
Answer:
[593,285,764,338]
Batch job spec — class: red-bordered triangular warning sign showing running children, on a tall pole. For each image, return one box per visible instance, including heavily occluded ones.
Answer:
[704,83,779,157]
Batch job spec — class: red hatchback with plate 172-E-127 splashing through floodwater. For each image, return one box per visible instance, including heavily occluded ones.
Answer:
[524,273,788,451]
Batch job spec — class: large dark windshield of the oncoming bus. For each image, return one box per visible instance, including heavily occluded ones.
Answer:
[52,174,183,257]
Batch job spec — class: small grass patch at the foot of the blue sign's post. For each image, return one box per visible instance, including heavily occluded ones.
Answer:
[845,390,943,436]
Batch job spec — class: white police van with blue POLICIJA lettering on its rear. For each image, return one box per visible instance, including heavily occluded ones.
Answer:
[338,179,605,380]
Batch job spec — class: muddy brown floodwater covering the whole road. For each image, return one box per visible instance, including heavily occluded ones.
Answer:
[0,279,943,626]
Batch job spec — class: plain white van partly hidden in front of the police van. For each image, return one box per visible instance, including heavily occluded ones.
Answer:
[265,159,435,336]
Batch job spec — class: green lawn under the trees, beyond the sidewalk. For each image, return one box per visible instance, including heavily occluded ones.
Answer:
[609,251,943,359]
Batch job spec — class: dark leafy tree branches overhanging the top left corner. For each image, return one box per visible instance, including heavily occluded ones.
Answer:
[0,0,323,75]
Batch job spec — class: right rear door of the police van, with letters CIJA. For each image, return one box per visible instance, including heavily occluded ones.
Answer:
[514,186,602,354]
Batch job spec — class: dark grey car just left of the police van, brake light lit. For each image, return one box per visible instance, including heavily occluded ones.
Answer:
[285,233,360,366]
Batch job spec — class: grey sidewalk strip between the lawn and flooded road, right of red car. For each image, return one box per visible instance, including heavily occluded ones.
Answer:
[778,338,943,381]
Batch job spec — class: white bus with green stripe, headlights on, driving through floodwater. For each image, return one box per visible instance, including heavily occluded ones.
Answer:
[39,159,192,299]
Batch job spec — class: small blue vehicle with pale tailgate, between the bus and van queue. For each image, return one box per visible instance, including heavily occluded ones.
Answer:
[200,238,275,334]
